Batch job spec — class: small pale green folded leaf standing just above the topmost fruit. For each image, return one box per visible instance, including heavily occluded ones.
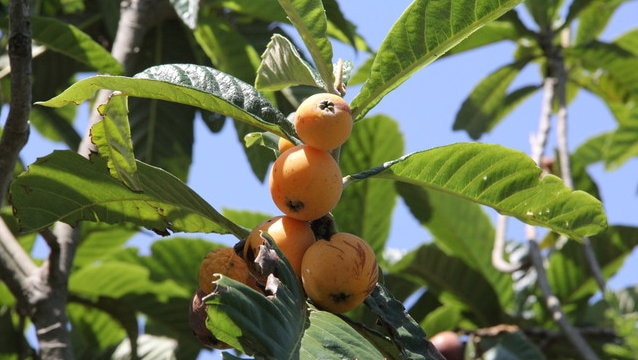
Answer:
[255,34,328,91]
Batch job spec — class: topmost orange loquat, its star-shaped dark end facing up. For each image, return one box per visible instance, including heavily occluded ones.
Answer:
[293,93,352,150]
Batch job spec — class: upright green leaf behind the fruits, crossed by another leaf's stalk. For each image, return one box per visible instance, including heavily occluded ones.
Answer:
[333,115,403,256]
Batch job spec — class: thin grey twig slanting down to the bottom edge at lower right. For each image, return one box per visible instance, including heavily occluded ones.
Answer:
[529,241,598,360]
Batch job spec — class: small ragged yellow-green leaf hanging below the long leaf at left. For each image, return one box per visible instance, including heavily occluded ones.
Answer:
[91,94,141,191]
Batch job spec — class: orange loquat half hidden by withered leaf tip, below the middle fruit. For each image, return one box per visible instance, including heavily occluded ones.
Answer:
[244,216,315,276]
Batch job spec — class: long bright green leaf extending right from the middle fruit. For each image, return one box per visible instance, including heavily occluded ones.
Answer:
[352,143,607,238]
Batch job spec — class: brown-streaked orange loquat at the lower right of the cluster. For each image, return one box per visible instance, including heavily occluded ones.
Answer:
[301,233,379,313]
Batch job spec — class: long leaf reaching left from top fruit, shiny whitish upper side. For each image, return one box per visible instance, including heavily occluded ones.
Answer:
[37,64,290,136]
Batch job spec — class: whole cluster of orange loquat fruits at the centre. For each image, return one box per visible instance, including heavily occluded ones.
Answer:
[191,93,379,348]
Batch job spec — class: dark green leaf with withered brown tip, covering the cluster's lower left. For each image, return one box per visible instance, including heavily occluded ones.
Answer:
[206,239,307,359]
